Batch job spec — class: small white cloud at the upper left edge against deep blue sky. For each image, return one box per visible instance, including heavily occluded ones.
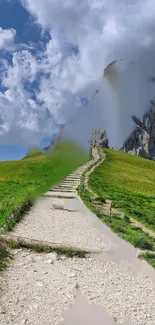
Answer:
[0,27,16,51]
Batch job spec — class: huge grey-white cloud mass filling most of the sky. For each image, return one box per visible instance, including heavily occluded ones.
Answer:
[0,0,155,145]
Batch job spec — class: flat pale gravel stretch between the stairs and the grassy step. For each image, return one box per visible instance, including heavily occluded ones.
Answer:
[11,209,105,250]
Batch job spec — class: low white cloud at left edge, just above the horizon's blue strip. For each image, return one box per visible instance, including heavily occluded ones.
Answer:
[0,89,57,146]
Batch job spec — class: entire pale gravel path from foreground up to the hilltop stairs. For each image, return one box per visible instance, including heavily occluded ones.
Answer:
[0,150,155,325]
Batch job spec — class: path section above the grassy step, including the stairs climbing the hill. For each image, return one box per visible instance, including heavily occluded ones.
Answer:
[10,150,105,250]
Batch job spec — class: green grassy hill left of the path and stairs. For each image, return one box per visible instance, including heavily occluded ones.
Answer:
[0,142,88,226]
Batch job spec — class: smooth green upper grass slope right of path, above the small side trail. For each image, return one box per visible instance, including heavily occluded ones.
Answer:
[89,149,155,230]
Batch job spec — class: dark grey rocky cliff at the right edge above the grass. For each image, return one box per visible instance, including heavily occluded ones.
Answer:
[121,101,155,160]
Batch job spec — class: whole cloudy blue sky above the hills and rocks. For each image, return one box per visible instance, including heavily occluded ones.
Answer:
[0,0,155,160]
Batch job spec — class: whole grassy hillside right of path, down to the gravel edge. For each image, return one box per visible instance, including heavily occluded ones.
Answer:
[79,149,155,267]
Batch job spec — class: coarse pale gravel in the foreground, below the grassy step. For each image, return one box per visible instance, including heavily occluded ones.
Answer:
[0,251,155,325]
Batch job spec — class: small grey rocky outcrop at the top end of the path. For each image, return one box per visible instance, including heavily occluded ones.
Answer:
[89,130,109,148]
